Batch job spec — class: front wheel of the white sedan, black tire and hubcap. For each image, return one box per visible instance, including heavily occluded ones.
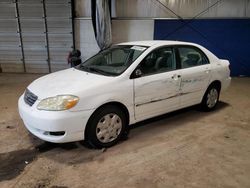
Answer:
[85,105,127,148]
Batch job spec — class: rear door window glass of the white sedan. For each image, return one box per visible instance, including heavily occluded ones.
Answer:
[178,47,209,68]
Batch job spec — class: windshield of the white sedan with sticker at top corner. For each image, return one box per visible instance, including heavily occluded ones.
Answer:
[76,46,147,76]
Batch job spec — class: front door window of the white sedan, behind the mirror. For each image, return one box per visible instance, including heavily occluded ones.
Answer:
[138,47,176,76]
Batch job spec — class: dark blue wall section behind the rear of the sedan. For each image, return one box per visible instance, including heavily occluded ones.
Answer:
[154,19,250,76]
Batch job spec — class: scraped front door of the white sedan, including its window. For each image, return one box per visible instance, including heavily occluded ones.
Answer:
[134,47,181,121]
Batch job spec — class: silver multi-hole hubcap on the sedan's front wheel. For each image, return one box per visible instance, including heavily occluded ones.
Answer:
[96,113,122,143]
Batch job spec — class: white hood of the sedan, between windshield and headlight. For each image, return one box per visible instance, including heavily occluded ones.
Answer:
[28,68,113,99]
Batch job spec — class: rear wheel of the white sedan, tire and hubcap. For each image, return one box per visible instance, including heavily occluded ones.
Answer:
[201,84,220,111]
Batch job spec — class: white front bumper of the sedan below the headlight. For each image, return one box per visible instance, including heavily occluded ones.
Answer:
[18,95,94,143]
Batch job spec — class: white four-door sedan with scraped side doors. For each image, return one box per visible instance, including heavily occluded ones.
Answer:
[18,41,231,148]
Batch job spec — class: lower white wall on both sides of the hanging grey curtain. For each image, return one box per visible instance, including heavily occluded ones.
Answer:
[75,19,154,60]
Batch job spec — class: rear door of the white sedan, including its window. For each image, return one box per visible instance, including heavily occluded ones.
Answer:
[177,46,211,107]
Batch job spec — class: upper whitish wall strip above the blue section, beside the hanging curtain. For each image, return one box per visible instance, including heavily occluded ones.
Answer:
[76,0,250,18]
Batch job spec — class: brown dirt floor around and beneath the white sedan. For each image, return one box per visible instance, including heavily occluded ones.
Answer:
[0,73,250,188]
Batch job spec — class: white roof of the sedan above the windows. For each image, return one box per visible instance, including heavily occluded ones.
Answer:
[118,40,197,47]
